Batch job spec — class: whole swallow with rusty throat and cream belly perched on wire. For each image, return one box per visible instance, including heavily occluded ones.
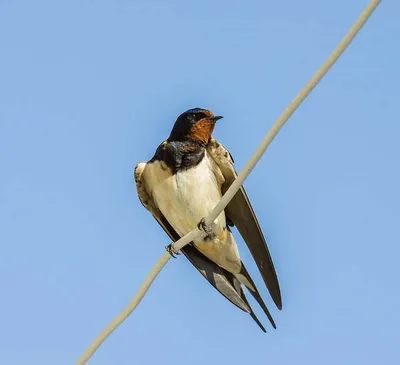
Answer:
[134,108,282,332]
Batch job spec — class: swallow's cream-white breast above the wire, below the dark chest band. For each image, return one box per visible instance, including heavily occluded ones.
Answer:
[144,152,226,236]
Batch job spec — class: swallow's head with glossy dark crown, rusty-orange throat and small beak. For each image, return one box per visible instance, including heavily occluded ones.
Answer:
[168,108,222,145]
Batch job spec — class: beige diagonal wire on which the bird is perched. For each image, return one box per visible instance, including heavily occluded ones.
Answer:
[76,0,381,365]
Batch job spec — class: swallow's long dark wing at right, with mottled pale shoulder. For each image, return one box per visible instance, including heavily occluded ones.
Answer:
[207,139,282,309]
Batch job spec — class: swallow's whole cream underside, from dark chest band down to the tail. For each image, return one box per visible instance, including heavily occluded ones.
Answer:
[145,155,240,273]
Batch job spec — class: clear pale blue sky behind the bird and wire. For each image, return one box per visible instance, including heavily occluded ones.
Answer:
[0,0,400,365]
